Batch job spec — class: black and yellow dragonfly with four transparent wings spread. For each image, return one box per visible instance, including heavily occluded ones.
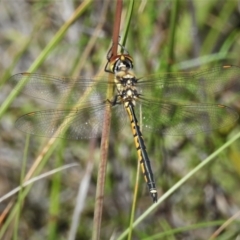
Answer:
[10,46,240,202]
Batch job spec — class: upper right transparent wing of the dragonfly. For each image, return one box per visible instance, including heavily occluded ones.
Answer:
[138,65,240,101]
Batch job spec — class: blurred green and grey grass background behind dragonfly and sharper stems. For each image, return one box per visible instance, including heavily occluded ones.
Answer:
[0,0,240,240]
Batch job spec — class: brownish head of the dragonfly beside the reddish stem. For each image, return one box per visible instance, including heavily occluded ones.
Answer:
[109,54,133,74]
